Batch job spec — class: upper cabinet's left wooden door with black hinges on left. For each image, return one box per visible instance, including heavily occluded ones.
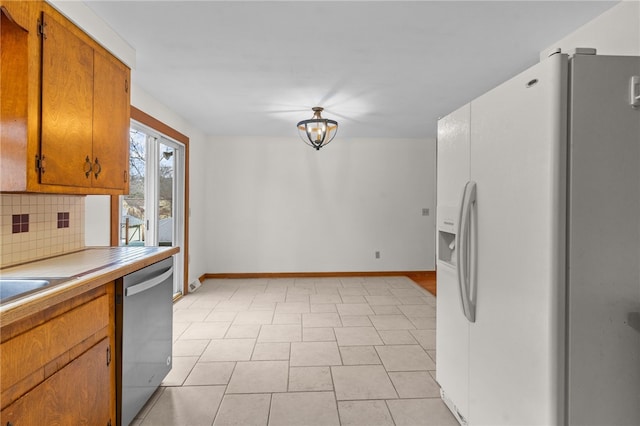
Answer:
[40,13,94,187]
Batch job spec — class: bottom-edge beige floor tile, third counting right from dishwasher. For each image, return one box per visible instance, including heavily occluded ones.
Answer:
[269,392,340,426]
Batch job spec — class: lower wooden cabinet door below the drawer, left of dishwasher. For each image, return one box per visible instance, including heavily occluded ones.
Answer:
[0,337,111,426]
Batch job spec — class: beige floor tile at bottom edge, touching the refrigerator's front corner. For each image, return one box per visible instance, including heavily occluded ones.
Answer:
[387,398,458,426]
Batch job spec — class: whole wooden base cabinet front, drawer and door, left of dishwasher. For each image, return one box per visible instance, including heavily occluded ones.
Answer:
[0,282,115,426]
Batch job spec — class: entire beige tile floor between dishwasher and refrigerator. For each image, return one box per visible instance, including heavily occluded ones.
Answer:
[133,277,457,426]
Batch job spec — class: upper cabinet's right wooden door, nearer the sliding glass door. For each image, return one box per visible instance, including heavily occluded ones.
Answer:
[92,51,130,192]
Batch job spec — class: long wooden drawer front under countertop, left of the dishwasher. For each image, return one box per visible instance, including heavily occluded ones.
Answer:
[0,295,109,406]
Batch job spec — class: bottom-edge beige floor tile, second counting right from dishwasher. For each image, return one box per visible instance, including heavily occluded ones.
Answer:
[213,394,271,426]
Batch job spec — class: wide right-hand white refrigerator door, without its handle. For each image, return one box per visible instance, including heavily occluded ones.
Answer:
[468,55,567,425]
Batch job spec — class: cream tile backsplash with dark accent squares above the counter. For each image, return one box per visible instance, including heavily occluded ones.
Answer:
[0,194,85,267]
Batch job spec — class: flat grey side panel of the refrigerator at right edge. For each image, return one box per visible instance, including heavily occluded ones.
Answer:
[567,56,640,425]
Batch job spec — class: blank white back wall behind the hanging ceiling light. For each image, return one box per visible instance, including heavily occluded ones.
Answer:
[204,135,435,272]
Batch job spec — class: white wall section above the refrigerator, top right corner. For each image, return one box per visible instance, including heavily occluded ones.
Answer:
[541,0,640,58]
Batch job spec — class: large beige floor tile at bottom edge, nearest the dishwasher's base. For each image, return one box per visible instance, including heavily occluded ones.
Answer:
[142,386,224,426]
